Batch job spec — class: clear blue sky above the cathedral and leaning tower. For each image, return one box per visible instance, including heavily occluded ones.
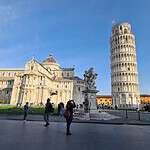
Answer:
[0,0,150,94]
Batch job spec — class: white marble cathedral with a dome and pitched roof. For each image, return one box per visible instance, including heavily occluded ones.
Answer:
[0,55,85,107]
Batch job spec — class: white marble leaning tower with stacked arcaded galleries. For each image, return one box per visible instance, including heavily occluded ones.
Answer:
[110,22,140,108]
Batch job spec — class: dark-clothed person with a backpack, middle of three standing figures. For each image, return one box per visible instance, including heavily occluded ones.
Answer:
[44,98,53,127]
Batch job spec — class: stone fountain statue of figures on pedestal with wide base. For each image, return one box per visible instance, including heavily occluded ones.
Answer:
[73,68,119,120]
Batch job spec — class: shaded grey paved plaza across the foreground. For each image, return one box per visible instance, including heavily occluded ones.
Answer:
[0,120,150,150]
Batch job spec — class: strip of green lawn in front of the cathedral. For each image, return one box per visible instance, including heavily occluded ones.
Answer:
[0,105,57,115]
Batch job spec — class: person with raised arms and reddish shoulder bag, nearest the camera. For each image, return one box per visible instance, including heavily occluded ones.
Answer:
[66,100,76,135]
